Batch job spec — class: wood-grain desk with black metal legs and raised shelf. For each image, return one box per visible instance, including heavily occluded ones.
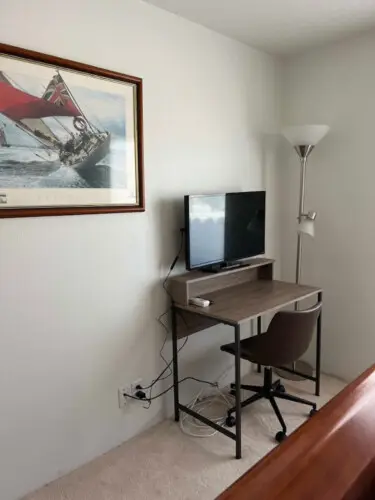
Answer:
[172,259,322,458]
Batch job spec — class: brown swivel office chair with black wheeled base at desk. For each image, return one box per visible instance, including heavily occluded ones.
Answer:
[220,302,322,443]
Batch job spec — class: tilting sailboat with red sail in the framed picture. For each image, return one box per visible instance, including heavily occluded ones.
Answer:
[0,71,111,177]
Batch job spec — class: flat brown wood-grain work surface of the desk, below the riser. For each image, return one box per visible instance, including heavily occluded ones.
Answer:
[175,280,322,325]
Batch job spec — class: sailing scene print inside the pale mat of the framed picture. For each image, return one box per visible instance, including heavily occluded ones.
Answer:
[0,64,127,189]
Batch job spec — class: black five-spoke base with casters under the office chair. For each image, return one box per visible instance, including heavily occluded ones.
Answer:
[225,368,317,443]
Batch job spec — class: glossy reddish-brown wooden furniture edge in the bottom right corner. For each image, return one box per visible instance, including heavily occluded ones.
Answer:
[218,365,375,500]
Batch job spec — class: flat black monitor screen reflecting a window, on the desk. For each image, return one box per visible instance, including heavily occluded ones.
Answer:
[185,191,266,269]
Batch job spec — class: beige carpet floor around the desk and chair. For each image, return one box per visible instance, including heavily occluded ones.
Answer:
[24,374,345,500]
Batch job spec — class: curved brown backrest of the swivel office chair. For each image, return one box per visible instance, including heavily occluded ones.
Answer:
[264,302,322,366]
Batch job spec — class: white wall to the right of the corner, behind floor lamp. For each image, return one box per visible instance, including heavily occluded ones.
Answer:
[282,32,375,379]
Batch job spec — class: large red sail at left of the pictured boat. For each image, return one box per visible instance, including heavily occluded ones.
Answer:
[0,81,81,121]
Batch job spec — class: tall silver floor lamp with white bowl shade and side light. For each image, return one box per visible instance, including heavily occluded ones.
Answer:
[280,125,329,380]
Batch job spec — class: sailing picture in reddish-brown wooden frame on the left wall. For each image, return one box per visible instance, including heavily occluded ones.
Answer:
[0,44,145,217]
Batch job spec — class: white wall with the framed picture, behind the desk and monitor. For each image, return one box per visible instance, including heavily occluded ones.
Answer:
[0,0,278,500]
